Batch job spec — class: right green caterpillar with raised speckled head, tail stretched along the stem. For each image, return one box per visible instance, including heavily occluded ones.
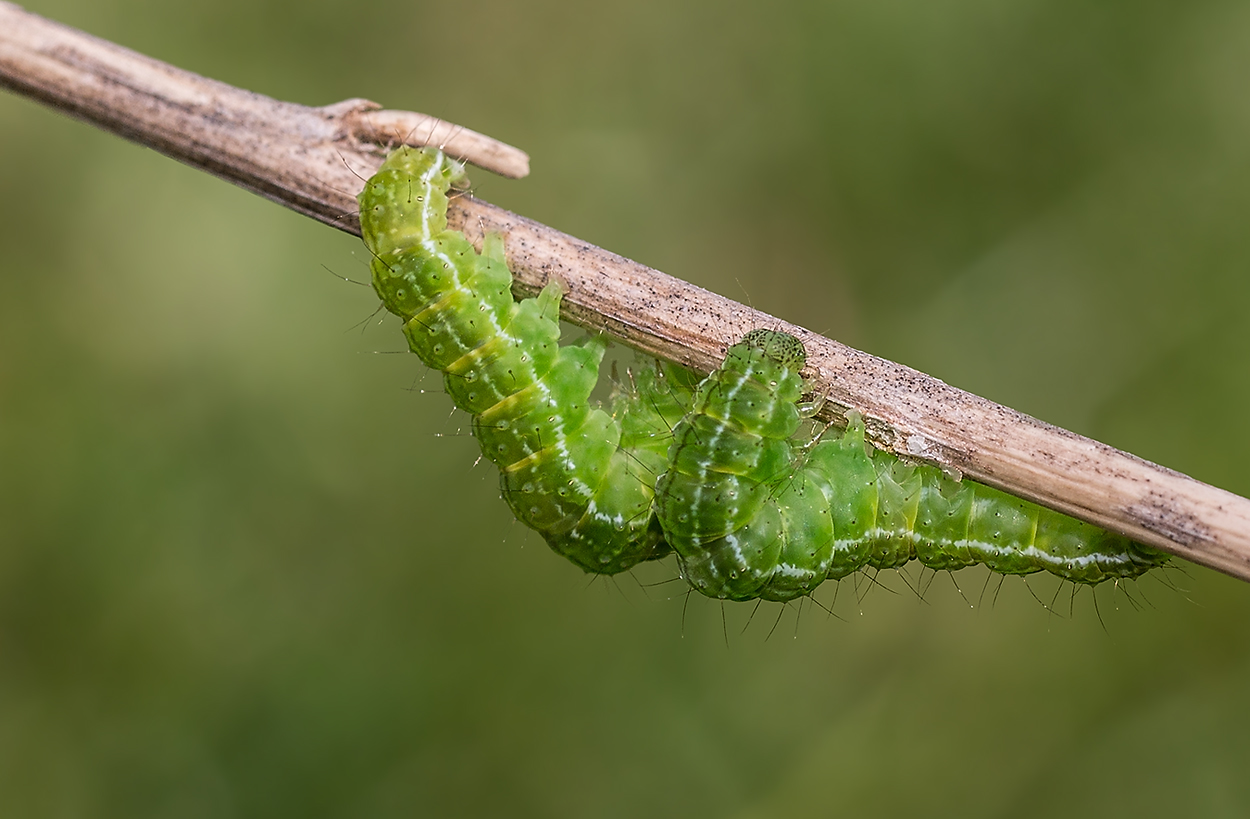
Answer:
[655,330,1168,601]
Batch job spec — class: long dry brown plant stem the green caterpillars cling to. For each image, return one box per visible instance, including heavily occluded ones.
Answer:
[0,3,1250,580]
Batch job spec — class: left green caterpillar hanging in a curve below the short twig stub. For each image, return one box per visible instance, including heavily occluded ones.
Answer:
[358,148,689,574]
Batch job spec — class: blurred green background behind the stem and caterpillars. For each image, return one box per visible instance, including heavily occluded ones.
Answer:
[0,0,1250,818]
